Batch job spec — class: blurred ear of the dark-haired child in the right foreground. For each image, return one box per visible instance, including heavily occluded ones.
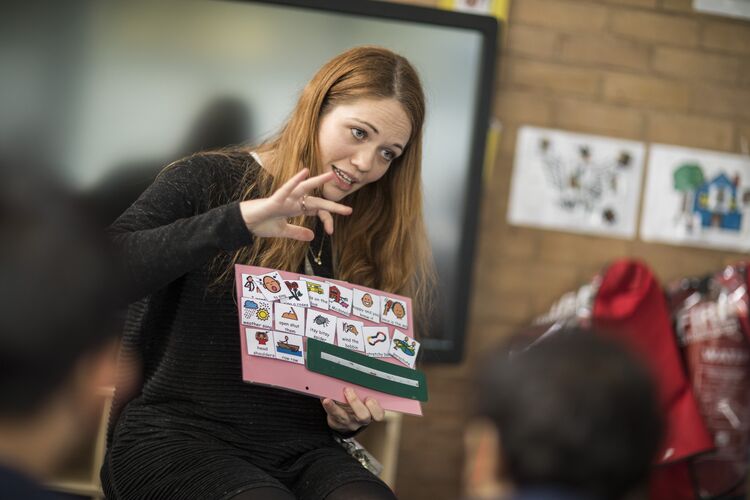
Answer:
[463,418,510,500]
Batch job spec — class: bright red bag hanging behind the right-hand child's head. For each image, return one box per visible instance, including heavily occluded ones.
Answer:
[519,260,713,500]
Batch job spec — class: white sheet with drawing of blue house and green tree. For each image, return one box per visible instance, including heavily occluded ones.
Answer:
[641,144,750,251]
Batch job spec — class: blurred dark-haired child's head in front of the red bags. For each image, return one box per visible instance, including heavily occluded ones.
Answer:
[467,329,661,499]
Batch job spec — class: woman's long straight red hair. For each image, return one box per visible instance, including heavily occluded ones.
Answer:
[225,46,434,336]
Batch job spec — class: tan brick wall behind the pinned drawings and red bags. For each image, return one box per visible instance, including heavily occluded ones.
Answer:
[388,0,750,499]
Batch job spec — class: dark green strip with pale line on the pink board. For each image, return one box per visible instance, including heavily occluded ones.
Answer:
[305,338,427,401]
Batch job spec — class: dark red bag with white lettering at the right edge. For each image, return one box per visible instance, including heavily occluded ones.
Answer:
[669,264,750,498]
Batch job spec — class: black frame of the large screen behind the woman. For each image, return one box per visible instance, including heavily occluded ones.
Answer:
[234,0,501,364]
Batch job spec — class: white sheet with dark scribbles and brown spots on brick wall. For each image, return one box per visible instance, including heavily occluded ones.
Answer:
[508,127,645,238]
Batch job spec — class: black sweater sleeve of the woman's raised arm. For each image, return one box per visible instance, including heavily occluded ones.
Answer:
[109,156,252,302]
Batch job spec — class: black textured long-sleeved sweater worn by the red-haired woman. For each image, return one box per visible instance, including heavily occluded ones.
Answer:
[106,154,340,450]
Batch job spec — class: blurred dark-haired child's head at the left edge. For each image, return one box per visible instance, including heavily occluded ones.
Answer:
[0,162,117,472]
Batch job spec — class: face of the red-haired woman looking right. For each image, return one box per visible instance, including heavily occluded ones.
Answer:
[318,98,411,201]
